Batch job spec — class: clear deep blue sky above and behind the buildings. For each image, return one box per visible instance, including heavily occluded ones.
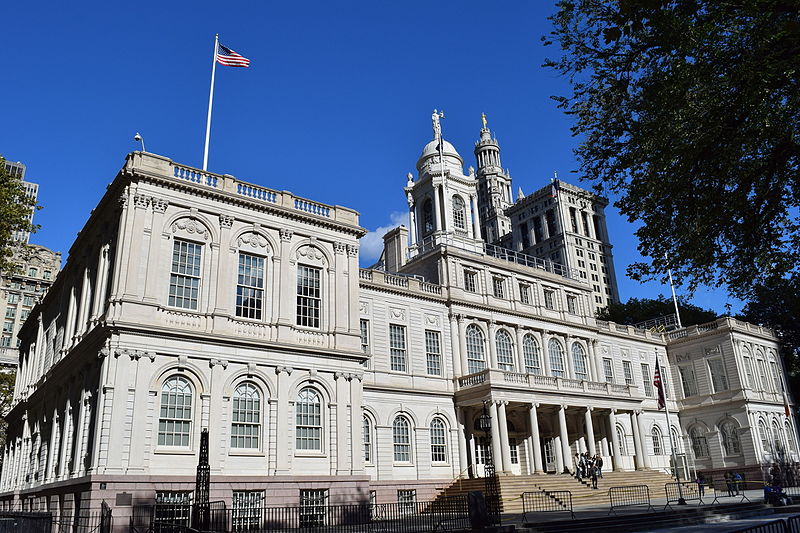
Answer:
[0,0,741,313]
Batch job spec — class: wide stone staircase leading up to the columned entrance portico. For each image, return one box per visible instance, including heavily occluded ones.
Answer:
[440,470,674,513]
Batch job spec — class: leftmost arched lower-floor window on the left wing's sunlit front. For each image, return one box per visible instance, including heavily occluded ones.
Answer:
[158,376,192,447]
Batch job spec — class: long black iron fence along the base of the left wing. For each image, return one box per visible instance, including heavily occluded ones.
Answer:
[138,496,471,533]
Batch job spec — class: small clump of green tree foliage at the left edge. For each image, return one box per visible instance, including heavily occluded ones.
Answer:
[0,156,37,272]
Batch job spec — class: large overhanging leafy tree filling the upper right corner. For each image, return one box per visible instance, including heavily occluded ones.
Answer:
[543,0,800,299]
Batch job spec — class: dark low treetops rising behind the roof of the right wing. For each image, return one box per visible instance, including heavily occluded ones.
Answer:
[597,295,717,326]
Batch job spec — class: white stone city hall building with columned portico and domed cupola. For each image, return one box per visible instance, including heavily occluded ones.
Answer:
[0,125,797,516]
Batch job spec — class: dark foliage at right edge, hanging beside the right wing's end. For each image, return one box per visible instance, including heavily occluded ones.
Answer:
[739,277,800,397]
